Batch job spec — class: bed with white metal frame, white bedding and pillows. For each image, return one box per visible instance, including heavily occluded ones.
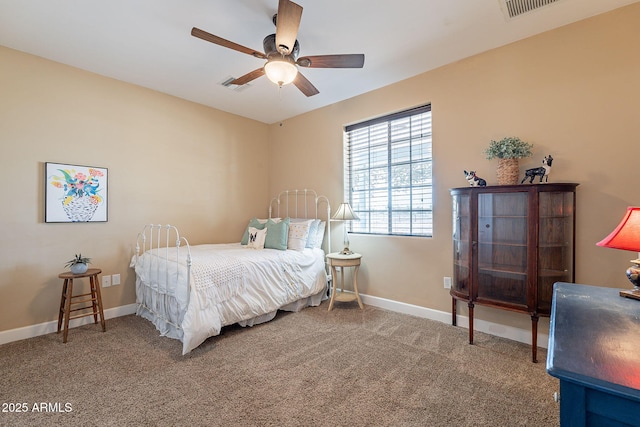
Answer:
[131,190,331,355]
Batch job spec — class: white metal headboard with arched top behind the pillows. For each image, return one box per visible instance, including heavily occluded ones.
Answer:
[269,189,331,253]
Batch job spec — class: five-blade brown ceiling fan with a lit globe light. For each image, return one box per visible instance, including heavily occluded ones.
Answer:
[191,0,364,96]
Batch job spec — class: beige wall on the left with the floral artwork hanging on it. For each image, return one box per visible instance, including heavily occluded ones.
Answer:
[0,47,269,331]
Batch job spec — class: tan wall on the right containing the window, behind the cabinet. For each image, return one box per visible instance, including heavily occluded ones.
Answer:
[269,4,640,328]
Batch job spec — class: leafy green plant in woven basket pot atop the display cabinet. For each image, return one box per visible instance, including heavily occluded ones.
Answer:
[484,136,533,185]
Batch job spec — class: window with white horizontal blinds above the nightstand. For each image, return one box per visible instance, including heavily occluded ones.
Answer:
[344,105,433,237]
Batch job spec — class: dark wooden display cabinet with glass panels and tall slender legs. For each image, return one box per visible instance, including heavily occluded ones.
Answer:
[451,183,578,362]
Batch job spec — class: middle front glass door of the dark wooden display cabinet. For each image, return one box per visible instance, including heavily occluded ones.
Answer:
[477,192,529,307]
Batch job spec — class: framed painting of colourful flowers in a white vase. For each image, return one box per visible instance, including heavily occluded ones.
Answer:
[44,162,108,222]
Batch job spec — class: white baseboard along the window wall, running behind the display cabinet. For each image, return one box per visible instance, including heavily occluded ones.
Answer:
[360,294,549,348]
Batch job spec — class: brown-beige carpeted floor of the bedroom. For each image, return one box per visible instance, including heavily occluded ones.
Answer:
[0,302,559,427]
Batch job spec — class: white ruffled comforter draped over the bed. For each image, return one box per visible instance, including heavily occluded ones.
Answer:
[132,243,327,354]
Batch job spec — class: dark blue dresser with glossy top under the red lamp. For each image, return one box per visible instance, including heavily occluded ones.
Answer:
[547,282,640,427]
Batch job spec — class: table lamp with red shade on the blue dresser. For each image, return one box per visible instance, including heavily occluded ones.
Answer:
[596,206,640,300]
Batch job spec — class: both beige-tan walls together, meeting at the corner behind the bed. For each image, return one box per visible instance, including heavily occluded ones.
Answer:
[0,4,640,338]
